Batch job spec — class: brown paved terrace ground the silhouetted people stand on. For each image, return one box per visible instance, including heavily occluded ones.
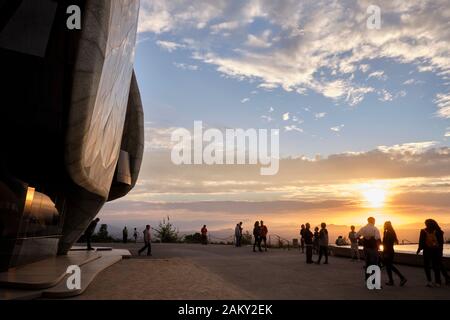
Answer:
[77,243,450,299]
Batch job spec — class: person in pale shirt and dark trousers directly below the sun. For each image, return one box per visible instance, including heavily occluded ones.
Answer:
[356,217,381,280]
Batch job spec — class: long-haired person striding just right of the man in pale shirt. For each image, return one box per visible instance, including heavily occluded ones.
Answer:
[383,221,407,286]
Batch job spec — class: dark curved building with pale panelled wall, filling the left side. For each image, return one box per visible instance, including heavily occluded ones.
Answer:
[0,0,144,271]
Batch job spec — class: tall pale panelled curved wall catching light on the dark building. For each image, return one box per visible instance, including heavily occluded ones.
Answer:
[66,0,139,199]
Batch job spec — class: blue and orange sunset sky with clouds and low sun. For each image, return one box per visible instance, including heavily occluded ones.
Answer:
[100,0,450,240]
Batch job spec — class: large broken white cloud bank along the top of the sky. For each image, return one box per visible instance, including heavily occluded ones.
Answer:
[139,0,450,105]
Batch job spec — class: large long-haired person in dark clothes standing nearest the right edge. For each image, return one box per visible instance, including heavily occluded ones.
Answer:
[417,219,444,287]
